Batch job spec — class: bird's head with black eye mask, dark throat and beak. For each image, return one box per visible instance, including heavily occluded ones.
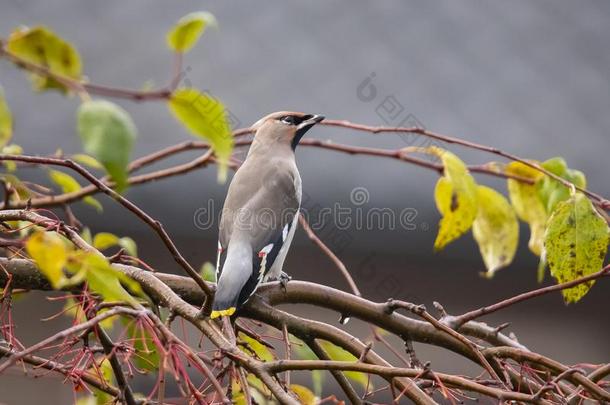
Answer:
[252,111,324,150]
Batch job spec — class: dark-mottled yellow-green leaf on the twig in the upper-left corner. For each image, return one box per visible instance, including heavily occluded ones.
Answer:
[6,26,82,92]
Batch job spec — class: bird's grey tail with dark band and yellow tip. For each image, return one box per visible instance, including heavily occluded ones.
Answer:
[210,240,252,319]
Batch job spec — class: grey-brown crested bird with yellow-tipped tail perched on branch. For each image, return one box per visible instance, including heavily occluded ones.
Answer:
[210,111,324,319]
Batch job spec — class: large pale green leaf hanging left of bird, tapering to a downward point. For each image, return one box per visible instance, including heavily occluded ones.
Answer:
[78,100,137,192]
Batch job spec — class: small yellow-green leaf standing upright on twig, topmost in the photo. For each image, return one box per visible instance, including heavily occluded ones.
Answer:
[166,11,217,53]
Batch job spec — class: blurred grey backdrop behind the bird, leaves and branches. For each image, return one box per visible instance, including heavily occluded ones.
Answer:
[0,0,610,405]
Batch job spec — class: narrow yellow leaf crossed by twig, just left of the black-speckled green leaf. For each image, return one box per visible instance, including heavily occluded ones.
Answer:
[506,162,548,256]
